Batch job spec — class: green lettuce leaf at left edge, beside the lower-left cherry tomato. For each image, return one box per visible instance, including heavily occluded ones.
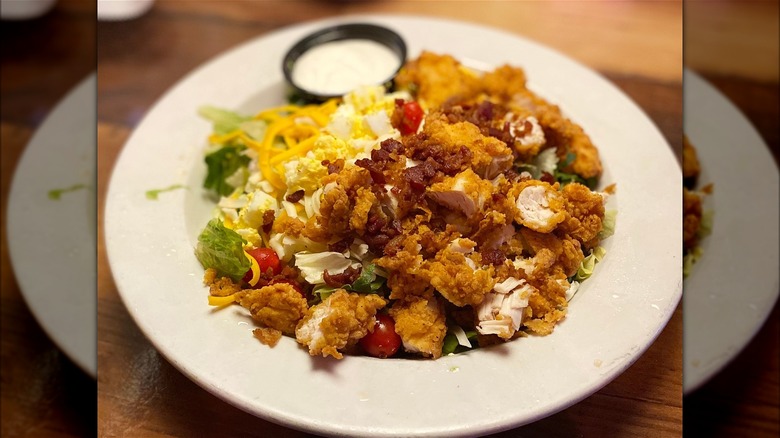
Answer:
[195,218,252,281]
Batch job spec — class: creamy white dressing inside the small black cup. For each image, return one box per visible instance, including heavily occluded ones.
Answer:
[292,39,401,95]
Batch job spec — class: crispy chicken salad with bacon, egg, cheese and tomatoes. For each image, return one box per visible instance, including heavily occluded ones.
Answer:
[195,52,615,359]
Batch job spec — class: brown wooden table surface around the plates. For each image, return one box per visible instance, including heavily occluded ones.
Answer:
[0,0,780,437]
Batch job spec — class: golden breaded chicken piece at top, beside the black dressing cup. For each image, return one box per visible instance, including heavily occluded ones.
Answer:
[395,51,480,108]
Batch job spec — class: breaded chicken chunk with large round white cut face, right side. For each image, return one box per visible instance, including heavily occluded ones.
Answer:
[509,180,567,233]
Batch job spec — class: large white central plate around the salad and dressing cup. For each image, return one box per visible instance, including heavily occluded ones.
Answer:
[105,16,682,436]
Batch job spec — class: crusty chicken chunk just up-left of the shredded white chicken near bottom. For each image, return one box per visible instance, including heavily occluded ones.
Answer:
[416,243,495,307]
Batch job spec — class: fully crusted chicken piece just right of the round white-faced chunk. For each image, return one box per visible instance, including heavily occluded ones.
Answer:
[559,183,604,248]
